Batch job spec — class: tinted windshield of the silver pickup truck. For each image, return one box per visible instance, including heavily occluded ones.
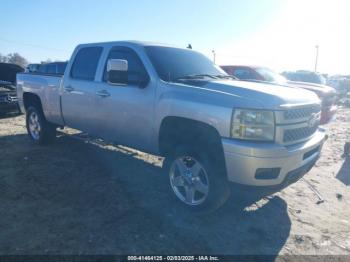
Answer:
[145,46,227,82]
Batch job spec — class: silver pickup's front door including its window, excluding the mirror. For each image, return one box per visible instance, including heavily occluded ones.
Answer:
[96,47,155,151]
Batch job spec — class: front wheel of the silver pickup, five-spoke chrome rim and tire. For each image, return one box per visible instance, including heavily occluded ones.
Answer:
[163,146,230,212]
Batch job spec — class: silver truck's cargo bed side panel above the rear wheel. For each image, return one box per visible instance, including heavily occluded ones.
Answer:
[17,73,64,125]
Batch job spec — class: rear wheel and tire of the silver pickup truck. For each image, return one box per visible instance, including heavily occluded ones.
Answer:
[26,106,56,145]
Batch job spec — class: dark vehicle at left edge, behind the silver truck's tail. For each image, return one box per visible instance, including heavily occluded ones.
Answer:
[0,63,24,115]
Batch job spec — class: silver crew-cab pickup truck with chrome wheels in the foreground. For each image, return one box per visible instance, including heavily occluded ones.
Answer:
[17,41,325,209]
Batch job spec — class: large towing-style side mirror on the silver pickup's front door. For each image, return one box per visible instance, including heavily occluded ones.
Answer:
[107,59,128,85]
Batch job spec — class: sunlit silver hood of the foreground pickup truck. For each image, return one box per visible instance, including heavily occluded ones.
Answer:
[192,80,320,109]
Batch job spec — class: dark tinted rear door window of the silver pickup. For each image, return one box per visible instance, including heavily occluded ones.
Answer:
[71,47,102,81]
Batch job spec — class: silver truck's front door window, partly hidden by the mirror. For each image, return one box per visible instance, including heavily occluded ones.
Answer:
[103,48,147,82]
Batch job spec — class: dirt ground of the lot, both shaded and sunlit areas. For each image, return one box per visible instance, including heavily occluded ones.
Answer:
[0,109,350,255]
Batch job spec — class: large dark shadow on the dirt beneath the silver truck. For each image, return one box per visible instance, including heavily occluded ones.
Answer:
[0,132,291,256]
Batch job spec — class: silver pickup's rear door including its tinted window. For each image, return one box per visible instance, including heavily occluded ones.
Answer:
[62,46,103,134]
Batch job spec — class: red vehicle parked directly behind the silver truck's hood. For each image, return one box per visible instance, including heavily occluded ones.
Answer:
[221,65,337,124]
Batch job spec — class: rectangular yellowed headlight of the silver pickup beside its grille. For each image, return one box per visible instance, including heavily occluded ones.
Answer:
[231,109,275,141]
